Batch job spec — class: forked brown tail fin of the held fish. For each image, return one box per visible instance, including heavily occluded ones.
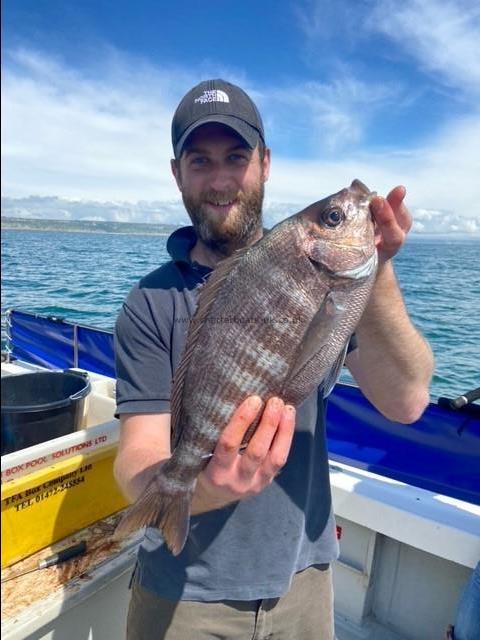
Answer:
[114,472,194,556]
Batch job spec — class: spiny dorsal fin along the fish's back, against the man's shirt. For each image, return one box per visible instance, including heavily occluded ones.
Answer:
[170,247,250,452]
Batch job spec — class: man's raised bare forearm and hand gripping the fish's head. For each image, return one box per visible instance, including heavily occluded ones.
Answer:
[346,187,433,423]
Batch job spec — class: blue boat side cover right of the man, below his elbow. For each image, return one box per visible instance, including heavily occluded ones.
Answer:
[327,384,480,505]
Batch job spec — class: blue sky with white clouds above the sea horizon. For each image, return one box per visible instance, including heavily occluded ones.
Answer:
[2,0,480,234]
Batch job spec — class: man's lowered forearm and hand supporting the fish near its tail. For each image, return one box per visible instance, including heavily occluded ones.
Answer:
[114,396,295,514]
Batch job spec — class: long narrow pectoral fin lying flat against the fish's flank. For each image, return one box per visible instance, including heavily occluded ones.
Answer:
[287,291,346,386]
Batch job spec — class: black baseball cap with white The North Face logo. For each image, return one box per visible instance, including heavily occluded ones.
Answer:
[172,80,265,158]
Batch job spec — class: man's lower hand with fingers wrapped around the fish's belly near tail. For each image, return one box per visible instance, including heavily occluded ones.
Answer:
[192,396,295,514]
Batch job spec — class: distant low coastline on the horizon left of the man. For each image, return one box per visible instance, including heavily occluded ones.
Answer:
[2,216,179,236]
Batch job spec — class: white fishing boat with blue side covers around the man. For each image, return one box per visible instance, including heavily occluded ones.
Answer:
[2,310,480,640]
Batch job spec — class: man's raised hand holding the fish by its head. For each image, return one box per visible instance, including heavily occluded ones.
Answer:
[370,186,412,264]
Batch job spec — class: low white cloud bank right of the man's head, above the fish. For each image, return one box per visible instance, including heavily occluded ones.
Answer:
[269,110,480,228]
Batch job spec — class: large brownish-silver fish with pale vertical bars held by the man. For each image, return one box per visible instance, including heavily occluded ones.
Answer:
[115,180,378,555]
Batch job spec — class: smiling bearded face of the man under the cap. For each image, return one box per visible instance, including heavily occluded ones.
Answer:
[172,123,270,255]
